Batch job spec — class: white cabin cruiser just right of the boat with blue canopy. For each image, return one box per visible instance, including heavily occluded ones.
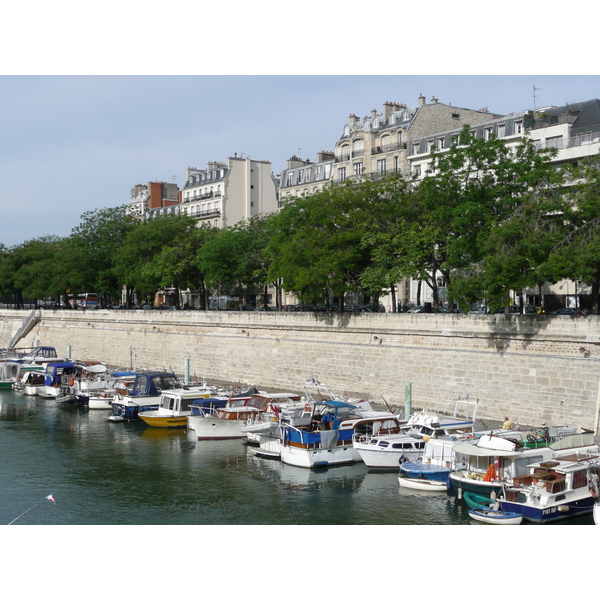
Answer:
[353,399,479,470]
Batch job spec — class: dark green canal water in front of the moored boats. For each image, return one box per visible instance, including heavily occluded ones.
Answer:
[0,391,592,533]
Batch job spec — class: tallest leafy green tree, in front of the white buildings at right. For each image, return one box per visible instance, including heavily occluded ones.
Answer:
[403,126,561,306]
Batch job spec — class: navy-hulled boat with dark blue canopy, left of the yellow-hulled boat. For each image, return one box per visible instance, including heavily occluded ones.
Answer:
[108,371,190,422]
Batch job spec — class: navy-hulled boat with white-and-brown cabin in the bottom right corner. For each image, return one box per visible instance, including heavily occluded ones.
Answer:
[500,452,600,523]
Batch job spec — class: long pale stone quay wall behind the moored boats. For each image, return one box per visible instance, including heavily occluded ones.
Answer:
[0,310,600,430]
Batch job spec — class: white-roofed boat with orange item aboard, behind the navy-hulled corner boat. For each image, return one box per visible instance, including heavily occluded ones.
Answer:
[450,425,598,497]
